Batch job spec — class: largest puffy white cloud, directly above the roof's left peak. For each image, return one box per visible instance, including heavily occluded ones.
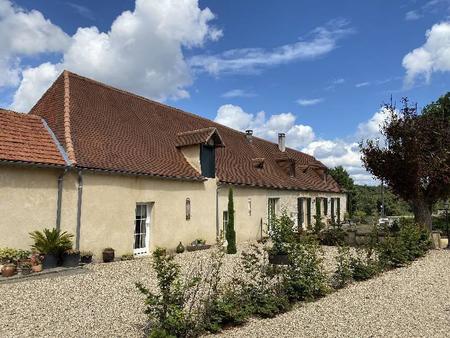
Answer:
[7,0,222,108]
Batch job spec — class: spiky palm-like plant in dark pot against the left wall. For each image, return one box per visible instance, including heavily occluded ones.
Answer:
[30,228,73,269]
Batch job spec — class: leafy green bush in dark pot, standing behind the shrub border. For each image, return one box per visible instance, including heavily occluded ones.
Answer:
[268,211,295,265]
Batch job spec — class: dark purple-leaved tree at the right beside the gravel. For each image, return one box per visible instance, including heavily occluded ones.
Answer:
[361,94,450,230]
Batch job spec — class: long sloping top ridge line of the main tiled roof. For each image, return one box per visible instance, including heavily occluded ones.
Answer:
[64,70,315,160]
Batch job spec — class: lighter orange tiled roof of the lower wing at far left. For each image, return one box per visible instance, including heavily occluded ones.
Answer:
[0,109,66,166]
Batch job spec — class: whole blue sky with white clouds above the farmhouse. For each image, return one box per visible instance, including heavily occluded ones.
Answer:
[0,0,450,184]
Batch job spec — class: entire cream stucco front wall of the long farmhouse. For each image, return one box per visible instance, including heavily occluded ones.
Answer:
[0,166,346,257]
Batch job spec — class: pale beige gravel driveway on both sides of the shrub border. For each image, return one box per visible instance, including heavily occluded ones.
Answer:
[0,248,450,338]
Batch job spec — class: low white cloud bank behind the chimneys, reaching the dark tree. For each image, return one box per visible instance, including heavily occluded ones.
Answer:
[215,104,388,184]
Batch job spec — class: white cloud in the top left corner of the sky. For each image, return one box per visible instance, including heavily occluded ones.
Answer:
[0,0,69,88]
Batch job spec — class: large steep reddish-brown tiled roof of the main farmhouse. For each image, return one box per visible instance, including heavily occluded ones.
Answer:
[31,71,340,192]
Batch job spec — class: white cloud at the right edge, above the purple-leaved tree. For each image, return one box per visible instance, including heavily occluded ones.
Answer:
[403,22,450,87]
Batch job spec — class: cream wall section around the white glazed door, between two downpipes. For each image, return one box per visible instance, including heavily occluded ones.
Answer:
[80,173,216,254]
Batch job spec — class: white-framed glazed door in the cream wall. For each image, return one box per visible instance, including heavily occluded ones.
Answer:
[133,204,151,256]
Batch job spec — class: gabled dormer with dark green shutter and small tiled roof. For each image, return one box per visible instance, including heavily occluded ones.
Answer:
[176,127,224,178]
